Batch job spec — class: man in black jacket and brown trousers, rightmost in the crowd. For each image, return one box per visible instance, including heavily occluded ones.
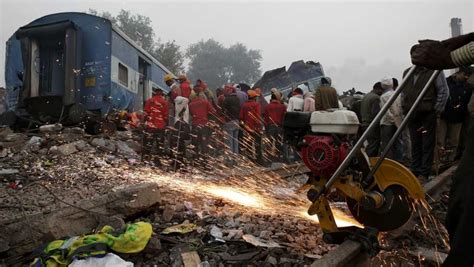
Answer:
[438,68,473,164]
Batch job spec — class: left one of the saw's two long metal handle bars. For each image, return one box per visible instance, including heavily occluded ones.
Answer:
[316,65,416,199]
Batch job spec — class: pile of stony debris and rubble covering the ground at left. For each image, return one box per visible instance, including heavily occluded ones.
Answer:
[0,125,340,266]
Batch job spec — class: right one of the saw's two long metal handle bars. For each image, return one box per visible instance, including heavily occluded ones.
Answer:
[366,70,440,180]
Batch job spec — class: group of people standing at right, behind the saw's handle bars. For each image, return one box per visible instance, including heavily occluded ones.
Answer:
[353,67,474,182]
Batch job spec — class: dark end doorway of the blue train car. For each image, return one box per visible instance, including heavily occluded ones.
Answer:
[16,21,81,116]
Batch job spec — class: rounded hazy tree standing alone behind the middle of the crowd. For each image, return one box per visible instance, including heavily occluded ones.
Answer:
[186,39,262,88]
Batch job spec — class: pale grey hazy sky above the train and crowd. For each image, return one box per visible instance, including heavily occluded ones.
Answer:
[0,0,474,92]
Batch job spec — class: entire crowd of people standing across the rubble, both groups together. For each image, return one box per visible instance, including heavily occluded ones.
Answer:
[138,63,472,182]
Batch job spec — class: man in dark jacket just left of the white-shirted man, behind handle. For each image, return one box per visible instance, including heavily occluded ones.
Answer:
[360,82,383,157]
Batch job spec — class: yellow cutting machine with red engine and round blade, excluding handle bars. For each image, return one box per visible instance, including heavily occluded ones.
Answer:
[283,109,424,247]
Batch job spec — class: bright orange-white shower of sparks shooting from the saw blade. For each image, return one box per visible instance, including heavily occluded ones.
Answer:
[146,169,363,227]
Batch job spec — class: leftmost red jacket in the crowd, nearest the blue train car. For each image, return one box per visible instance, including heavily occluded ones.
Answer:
[145,95,168,129]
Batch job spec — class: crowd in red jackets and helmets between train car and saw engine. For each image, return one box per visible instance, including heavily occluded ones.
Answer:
[137,74,341,170]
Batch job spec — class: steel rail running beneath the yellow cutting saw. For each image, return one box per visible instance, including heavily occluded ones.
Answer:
[311,165,457,267]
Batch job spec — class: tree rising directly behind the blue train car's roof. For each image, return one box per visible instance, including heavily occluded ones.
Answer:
[89,9,184,74]
